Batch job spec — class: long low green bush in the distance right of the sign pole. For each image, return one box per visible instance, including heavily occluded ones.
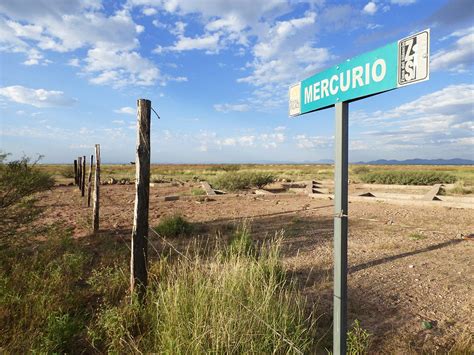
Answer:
[360,170,456,185]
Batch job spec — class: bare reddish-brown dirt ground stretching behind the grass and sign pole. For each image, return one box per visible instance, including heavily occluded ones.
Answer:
[41,184,474,353]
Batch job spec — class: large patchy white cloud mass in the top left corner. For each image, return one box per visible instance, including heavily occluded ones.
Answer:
[0,0,166,87]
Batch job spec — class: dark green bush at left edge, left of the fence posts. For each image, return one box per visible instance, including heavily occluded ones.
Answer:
[0,153,54,241]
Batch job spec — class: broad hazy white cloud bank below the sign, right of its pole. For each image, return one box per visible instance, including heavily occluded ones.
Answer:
[351,84,474,158]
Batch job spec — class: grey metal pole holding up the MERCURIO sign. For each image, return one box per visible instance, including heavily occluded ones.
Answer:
[333,102,349,355]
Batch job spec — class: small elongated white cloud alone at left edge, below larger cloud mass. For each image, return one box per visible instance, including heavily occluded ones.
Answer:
[0,85,77,107]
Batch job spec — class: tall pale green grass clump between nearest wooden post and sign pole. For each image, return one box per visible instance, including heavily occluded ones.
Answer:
[89,234,314,354]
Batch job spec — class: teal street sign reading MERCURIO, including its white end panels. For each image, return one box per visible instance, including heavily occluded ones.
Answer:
[289,29,430,116]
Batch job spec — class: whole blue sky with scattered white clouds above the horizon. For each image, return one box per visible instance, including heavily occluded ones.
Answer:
[0,0,474,163]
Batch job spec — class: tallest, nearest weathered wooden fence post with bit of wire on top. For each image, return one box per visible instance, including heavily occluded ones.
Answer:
[130,99,151,301]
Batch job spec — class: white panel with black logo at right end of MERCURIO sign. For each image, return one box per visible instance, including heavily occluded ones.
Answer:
[397,29,430,87]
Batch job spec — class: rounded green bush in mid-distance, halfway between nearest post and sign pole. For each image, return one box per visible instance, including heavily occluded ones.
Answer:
[212,171,275,191]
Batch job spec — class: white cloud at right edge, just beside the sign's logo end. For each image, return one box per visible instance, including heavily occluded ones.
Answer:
[431,27,474,73]
